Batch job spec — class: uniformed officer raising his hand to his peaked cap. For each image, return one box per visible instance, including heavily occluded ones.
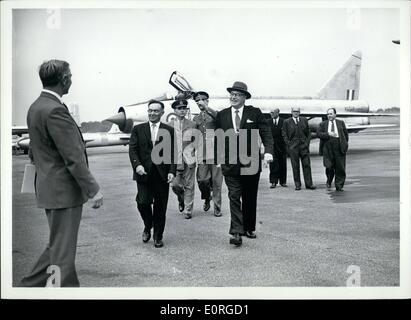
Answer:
[193,91,223,217]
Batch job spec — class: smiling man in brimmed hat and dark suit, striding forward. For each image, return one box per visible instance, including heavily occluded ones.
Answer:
[215,82,273,246]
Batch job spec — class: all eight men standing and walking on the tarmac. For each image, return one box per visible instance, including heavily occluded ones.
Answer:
[21,60,348,287]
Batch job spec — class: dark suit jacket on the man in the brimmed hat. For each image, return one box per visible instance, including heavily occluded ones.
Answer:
[215,106,274,176]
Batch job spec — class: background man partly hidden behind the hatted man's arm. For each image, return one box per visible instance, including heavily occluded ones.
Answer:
[270,108,287,188]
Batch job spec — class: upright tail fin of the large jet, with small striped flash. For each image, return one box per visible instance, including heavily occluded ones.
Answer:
[318,51,361,100]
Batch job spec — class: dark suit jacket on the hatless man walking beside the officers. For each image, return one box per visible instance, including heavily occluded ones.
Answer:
[129,122,176,182]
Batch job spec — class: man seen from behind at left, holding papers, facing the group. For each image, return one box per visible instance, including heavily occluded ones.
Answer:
[21,60,103,287]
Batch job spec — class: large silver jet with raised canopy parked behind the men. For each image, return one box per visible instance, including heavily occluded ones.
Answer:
[106,51,400,138]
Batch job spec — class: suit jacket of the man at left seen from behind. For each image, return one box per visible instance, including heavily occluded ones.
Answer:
[27,92,99,209]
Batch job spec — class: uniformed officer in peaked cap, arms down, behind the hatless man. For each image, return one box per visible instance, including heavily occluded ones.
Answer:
[169,99,197,219]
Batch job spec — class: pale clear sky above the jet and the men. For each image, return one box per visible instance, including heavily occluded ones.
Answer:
[12,6,400,125]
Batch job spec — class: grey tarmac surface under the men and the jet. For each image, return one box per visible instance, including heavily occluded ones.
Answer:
[12,128,400,287]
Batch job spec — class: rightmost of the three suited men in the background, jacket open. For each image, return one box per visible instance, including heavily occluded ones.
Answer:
[317,108,348,191]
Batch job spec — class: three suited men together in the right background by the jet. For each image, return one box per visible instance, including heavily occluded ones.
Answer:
[270,107,348,191]
